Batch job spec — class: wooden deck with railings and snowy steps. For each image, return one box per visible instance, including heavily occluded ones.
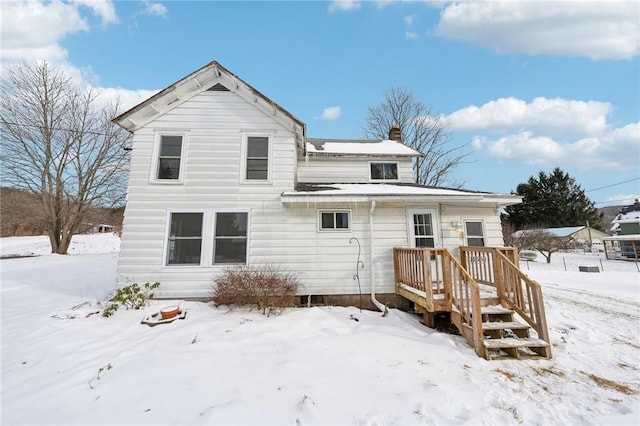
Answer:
[393,247,551,359]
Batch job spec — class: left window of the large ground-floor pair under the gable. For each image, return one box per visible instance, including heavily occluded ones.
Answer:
[167,213,203,265]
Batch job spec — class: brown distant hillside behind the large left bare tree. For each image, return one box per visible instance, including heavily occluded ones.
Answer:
[0,187,124,237]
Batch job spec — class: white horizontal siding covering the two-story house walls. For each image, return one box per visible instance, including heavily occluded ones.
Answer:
[118,84,510,298]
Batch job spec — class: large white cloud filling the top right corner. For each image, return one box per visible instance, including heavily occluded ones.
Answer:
[435,0,640,59]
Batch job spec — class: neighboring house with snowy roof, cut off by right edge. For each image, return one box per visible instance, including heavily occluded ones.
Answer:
[605,199,640,260]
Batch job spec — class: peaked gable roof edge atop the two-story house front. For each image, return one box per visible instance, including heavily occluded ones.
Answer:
[113,61,306,150]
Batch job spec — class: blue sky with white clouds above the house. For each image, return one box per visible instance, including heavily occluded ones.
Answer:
[0,0,640,207]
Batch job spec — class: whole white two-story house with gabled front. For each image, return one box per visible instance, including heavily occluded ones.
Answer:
[114,62,521,304]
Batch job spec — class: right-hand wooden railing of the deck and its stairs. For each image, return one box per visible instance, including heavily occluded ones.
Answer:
[460,247,550,357]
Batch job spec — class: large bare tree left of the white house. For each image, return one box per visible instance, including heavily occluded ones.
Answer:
[0,62,128,254]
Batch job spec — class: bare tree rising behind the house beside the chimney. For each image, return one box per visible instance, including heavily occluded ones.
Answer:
[362,87,469,187]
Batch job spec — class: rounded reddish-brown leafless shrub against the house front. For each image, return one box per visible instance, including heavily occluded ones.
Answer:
[213,265,298,315]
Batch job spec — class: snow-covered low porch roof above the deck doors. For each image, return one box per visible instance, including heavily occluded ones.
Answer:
[281,183,522,206]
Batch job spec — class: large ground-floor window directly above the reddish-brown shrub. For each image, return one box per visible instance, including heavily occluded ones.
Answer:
[213,212,249,264]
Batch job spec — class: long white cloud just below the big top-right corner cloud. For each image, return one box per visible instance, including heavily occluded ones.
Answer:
[446,97,612,136]
